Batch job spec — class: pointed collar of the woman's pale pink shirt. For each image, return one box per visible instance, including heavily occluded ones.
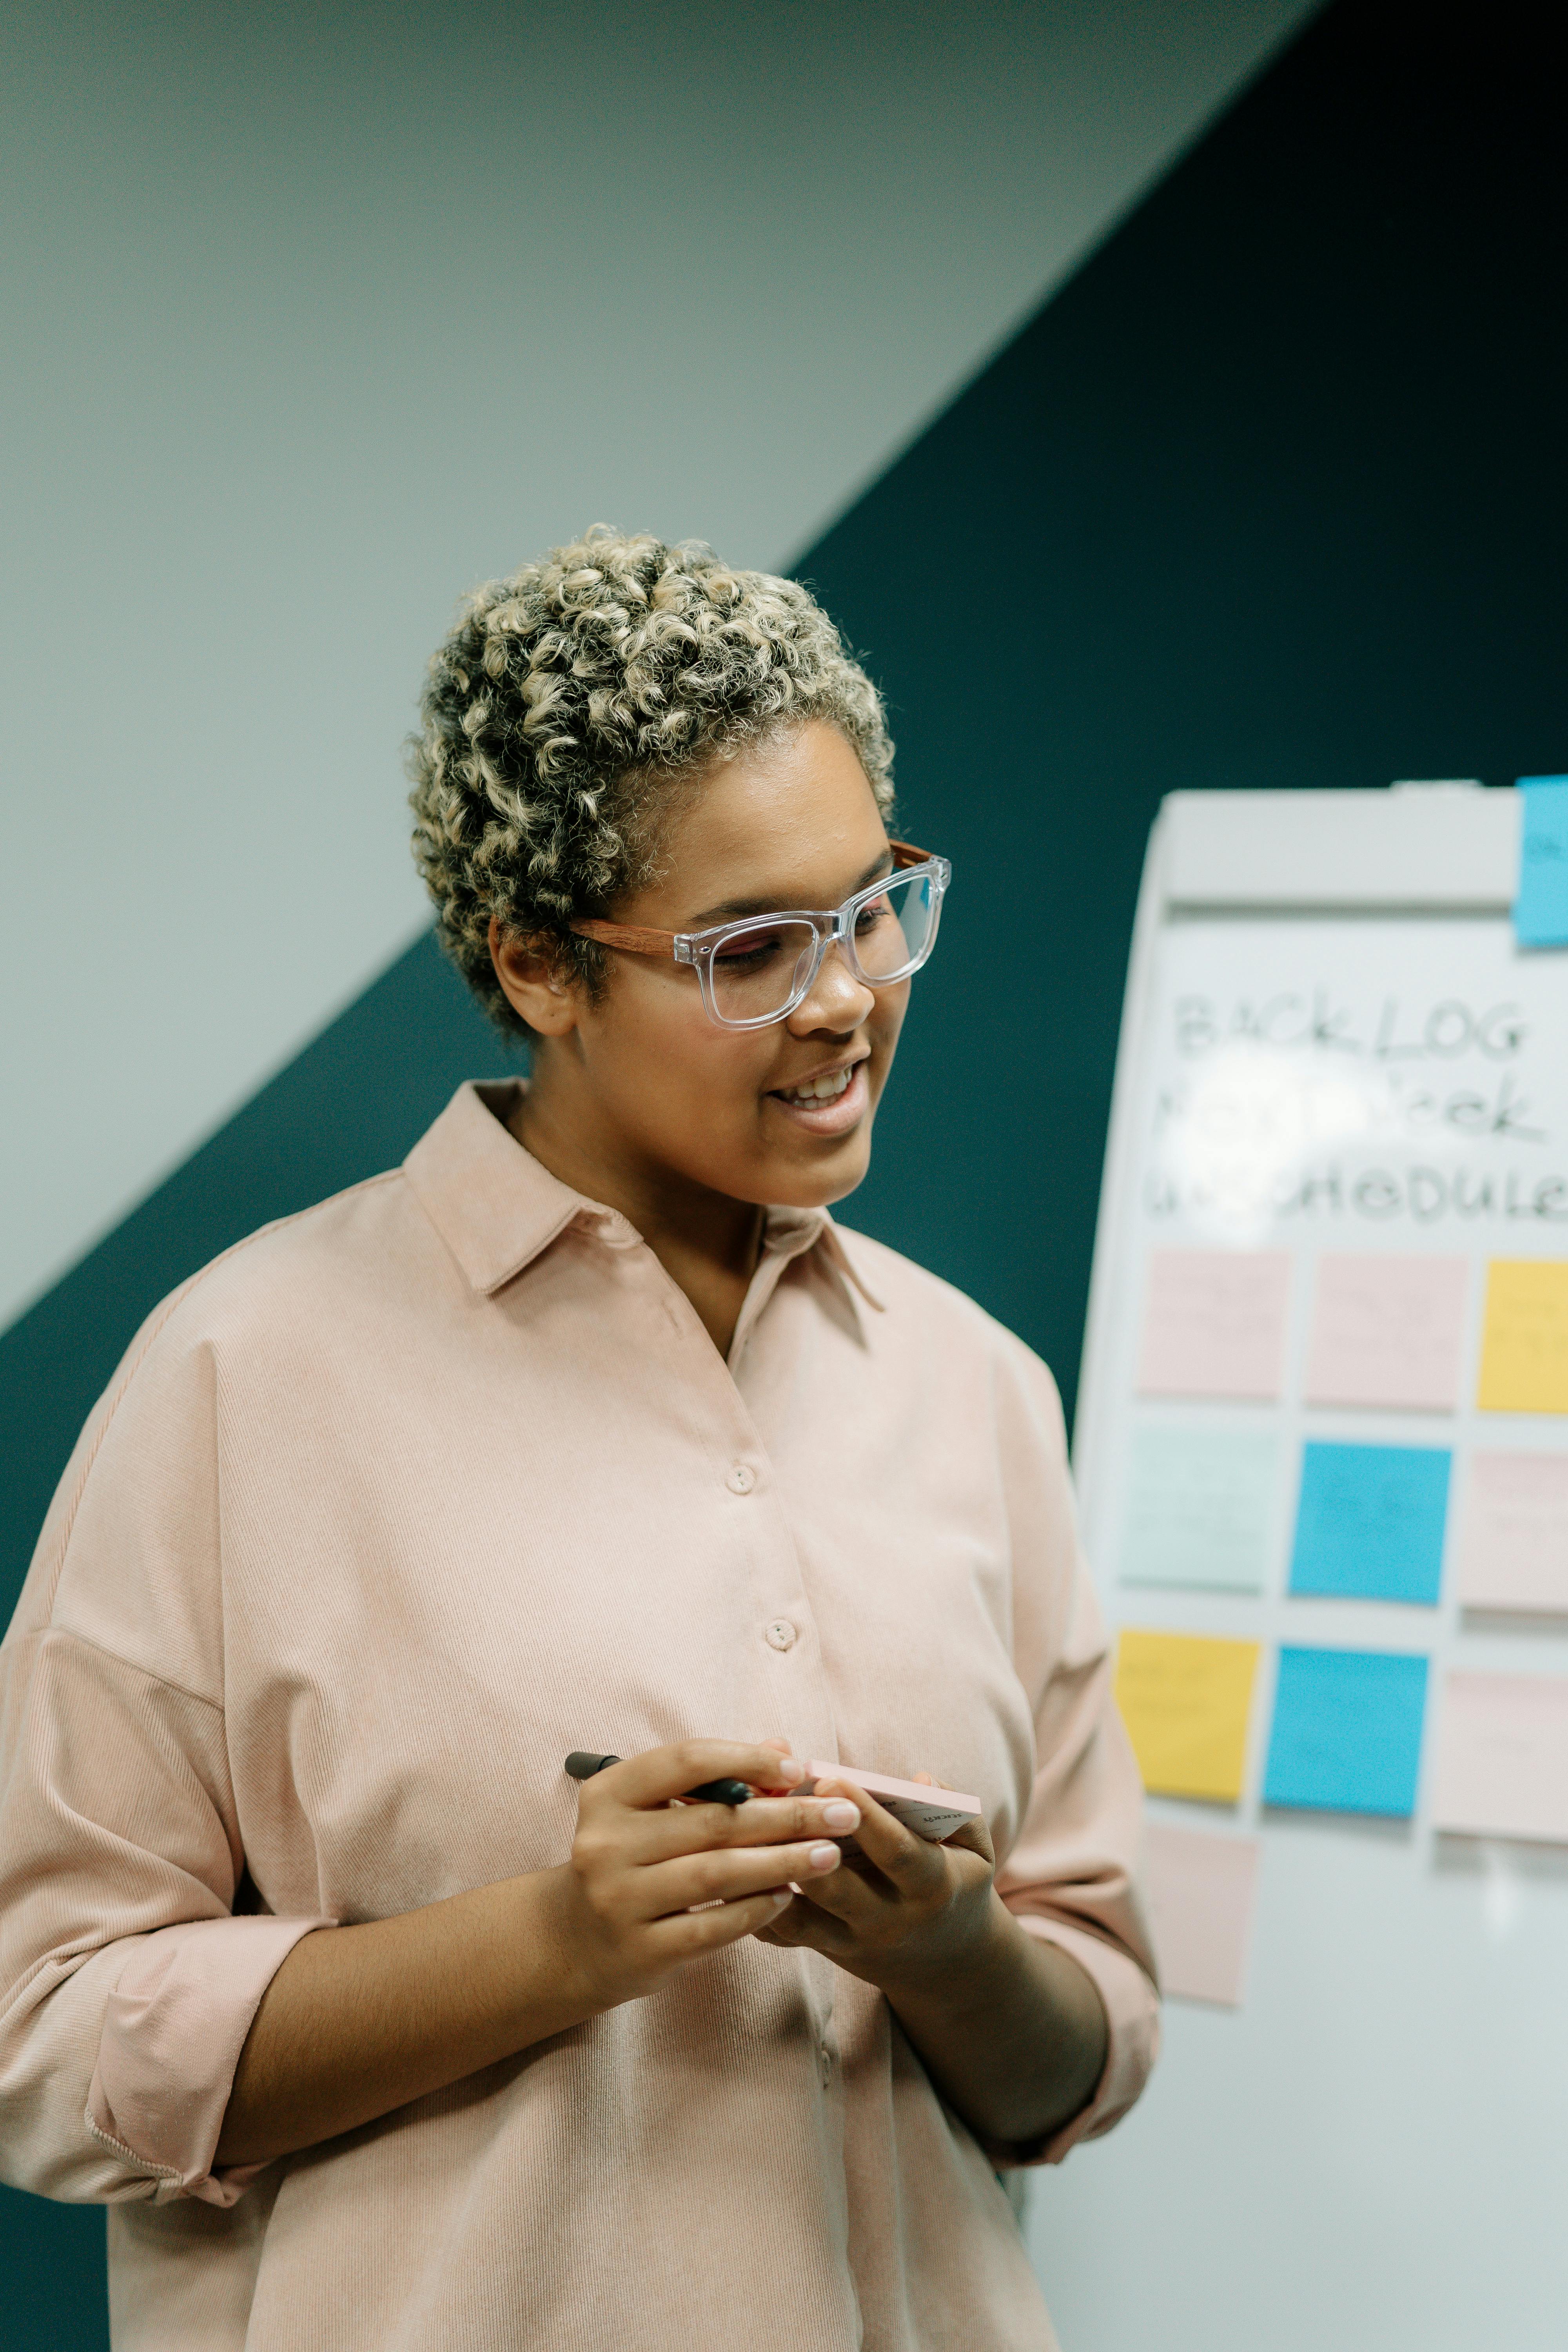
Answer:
[402,1077,882,1308]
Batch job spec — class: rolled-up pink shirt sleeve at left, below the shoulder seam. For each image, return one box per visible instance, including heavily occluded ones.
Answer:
[0,1632,332,2204]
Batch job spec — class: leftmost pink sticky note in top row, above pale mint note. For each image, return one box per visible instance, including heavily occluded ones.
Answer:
[1138,1249,1290,1397]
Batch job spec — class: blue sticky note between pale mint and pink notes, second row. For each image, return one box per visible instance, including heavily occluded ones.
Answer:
[1290,1439,1453,1609]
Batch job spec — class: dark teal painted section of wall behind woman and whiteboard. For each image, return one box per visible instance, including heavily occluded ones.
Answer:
[0,0,1568,2352]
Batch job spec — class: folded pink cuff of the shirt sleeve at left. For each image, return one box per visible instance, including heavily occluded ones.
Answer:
[87,1917,336,2206]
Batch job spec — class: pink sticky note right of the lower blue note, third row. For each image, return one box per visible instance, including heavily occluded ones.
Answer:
[1432,1675,1568,1844]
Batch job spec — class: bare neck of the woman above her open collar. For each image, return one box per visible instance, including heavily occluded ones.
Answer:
[508,1084,766,1357]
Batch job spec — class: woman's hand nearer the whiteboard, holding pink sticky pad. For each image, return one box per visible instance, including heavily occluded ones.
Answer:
[757,1773,997,1992]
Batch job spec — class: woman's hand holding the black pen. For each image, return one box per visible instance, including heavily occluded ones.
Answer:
[552,1740,860,2011]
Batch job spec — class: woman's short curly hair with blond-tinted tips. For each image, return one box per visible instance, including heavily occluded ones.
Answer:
[409,524,893,1035]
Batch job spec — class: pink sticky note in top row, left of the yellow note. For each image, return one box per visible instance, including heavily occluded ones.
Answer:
[1302,1256,1469,1414]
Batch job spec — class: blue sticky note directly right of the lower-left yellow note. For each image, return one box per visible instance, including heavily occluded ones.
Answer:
[1262,1649,1427,1816]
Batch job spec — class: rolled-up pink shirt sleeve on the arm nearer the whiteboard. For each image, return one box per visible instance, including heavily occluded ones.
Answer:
[995,1350,1159,2164]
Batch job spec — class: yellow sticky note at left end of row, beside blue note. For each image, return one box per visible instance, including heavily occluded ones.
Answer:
[1117,1628,1258,1804]
